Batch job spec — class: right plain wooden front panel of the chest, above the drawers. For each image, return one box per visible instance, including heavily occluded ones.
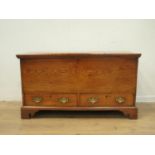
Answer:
[78,57,137,93]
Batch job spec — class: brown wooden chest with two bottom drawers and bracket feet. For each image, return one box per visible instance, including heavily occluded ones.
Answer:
[17,53,141,119]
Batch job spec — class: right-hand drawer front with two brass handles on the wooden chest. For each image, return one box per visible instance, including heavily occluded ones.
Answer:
[78,94,134,107]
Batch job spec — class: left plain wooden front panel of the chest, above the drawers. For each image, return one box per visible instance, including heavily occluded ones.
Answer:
[21,59,77,93]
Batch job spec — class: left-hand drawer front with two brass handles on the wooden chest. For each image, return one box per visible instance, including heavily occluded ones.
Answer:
[24,93,77,107]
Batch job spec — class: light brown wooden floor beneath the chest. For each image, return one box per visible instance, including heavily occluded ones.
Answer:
[0,102,155,135]
